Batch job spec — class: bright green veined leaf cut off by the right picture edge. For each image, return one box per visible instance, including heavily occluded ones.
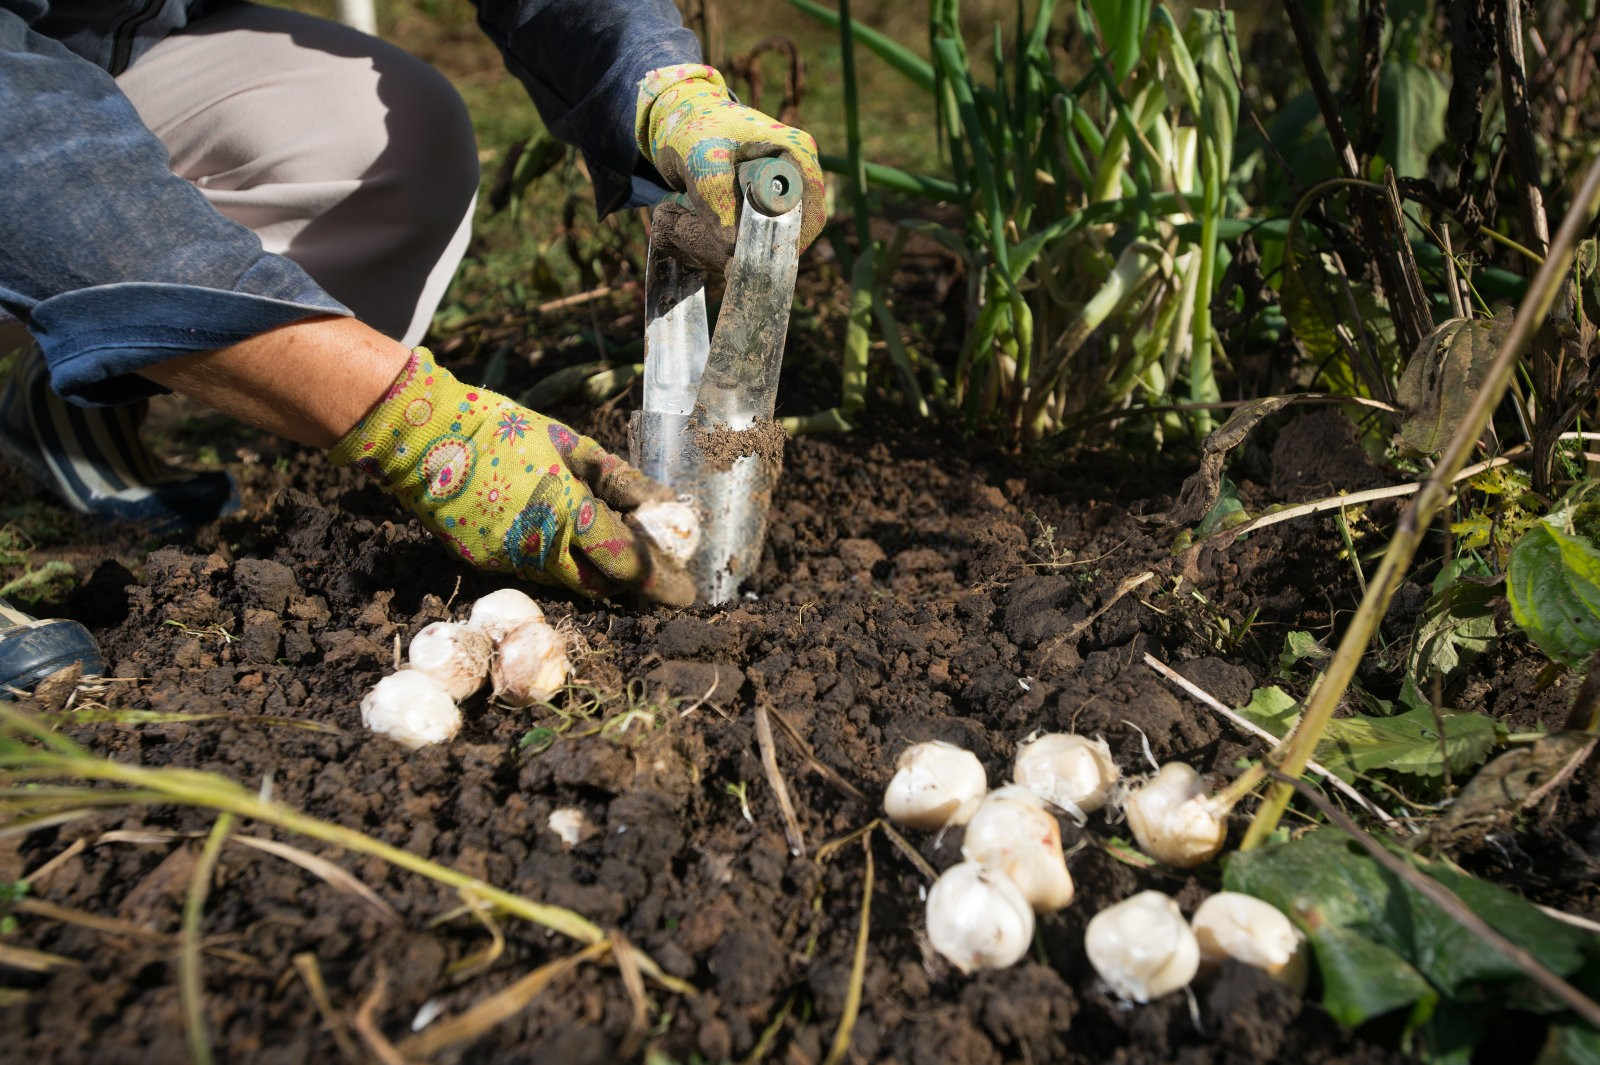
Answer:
[1506,520,1600,665]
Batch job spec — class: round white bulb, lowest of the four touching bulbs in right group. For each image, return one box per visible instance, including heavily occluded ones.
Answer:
[928,862,1034,972]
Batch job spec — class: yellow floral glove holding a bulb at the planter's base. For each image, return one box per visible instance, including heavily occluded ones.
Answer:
[331,347,694,606]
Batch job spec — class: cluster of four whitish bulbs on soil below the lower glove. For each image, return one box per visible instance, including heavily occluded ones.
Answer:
[362,588,571,750]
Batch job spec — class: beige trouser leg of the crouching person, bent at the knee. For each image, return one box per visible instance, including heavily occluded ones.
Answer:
[0,3,478,345]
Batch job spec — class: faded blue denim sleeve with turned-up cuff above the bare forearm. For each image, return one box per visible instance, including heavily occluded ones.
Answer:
[0,8,349,403]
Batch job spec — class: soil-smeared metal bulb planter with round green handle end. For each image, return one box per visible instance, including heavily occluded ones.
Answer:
[632,158,802,604]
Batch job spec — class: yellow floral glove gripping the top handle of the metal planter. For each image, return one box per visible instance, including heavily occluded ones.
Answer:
[634,62,826,272]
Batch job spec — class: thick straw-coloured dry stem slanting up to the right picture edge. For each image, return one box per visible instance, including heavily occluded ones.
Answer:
[1240,157,1600,851]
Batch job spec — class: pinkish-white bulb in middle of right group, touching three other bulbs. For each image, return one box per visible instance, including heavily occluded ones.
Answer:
[962,784,1072,913]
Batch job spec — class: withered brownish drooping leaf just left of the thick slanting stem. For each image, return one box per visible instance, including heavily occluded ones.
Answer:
[1395,318,1507,454]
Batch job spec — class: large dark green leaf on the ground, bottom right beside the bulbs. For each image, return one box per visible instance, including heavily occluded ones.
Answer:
[1222,828,1594,1025]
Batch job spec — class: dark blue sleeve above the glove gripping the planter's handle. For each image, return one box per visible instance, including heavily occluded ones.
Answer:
[474,0,701,214]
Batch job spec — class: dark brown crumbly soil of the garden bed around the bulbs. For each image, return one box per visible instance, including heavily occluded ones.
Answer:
[0,343,1600,1065]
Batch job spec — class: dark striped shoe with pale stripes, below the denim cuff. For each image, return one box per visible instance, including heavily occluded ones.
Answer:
[0,347,238,533]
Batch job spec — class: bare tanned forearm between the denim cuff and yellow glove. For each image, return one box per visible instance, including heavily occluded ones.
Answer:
[141,318,410,448]
